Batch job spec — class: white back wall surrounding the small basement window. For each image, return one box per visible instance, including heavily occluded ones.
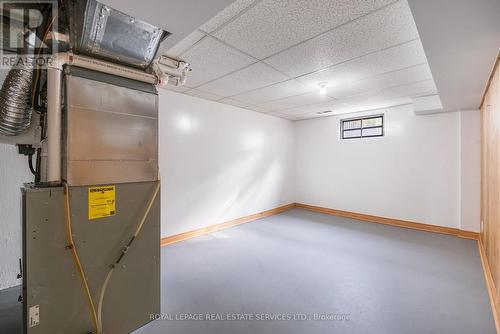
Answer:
[295,106,479,231]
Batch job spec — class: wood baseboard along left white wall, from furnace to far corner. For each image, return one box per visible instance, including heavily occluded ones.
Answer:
[161,203,295,246]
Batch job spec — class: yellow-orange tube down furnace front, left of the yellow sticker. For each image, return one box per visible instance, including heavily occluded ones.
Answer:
[64,183,100,333]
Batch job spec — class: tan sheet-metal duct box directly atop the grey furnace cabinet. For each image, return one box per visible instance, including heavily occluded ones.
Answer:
[63,67,158,186]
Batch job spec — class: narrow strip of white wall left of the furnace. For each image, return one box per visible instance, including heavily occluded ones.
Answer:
[0,144,33,289]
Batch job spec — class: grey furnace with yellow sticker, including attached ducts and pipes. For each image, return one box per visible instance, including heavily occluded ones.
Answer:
[0,0,188,334]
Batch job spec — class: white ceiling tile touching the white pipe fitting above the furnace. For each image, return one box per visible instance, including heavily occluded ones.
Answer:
[182,36,255,87]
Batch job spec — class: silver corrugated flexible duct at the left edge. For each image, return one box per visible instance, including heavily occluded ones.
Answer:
[0,32,34,136]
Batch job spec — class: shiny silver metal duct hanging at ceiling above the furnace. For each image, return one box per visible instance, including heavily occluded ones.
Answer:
[70,0,170,69]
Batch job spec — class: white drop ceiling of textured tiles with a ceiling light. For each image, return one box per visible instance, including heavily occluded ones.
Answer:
[166,0,437,120]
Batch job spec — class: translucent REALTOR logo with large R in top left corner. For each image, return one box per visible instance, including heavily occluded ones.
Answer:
[0,0,58,68]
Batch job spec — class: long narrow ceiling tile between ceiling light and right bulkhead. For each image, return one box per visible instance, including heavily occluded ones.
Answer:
[328,64,432,99]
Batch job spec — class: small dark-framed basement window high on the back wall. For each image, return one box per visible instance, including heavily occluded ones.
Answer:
[340,115,384,139]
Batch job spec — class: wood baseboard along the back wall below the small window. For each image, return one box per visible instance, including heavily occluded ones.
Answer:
[295,203,479,240]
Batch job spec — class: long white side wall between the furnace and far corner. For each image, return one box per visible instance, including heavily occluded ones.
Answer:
[160,91,295,236]
